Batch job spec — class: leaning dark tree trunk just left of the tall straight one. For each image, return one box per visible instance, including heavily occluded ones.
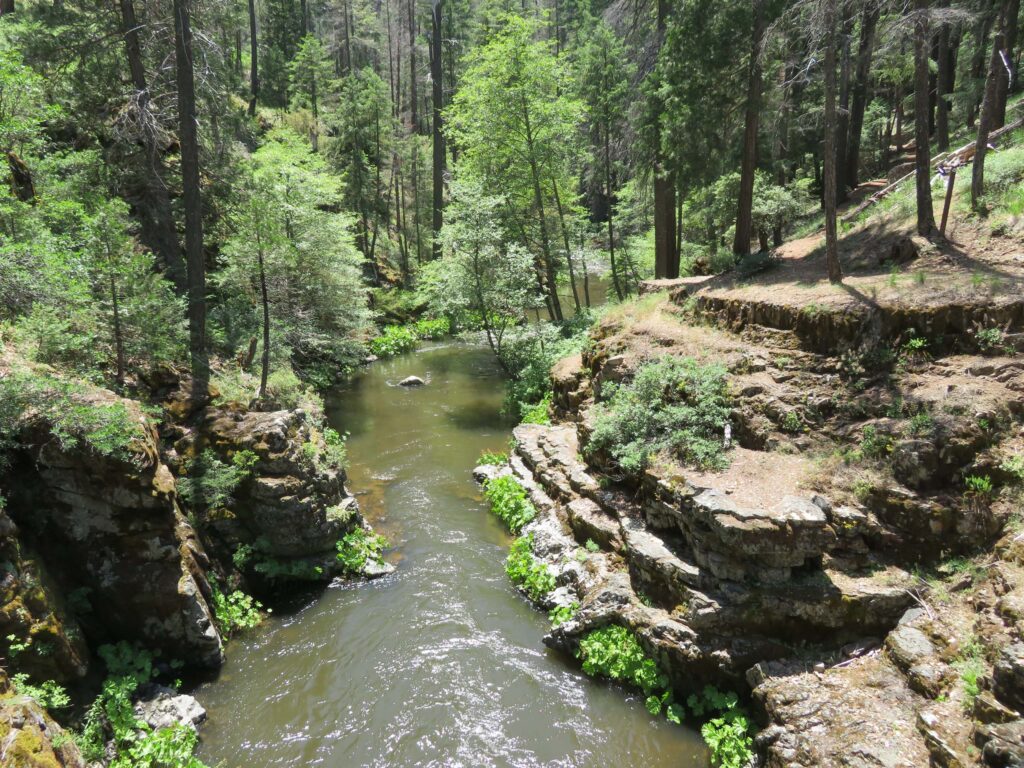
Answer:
[121,0,187,293]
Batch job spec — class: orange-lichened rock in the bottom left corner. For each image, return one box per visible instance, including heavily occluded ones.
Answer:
[0,672,85,768]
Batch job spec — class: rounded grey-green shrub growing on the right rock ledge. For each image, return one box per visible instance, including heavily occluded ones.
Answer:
[586,356,729,474]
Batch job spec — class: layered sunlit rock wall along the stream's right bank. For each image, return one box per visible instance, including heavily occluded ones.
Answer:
[485,287,1024,768]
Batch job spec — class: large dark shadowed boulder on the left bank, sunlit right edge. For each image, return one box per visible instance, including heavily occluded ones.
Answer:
[8,390,221,667]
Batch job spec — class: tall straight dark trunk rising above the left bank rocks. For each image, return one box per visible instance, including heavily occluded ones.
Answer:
[173,0,210,402]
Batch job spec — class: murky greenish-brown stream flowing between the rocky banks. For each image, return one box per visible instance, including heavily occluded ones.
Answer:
[197,343,708,768]
